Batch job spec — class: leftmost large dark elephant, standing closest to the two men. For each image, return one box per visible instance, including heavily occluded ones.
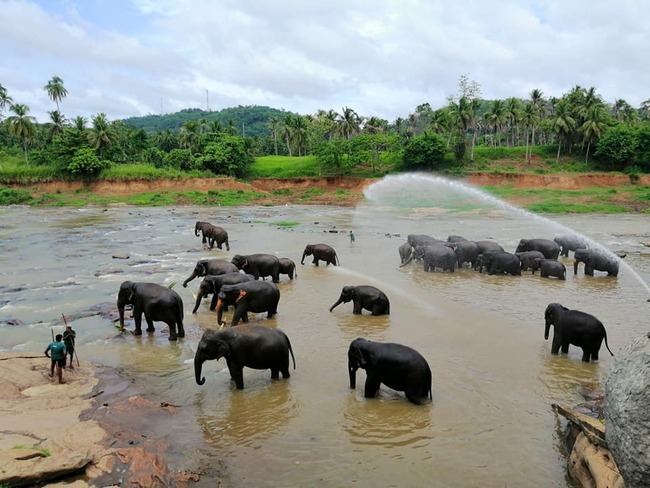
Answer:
[117,281,185,341]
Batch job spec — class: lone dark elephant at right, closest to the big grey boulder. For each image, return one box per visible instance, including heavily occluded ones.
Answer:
[544,303,614,363]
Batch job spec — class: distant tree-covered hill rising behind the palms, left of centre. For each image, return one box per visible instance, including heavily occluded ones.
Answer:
[124,105,296,137]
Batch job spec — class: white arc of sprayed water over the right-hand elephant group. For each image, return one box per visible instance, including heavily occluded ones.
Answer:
[364,173,650,294]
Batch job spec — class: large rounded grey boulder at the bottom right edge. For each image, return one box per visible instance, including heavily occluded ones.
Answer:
[605,336,650,488]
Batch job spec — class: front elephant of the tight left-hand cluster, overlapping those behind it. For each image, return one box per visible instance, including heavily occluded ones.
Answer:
[217,280,280,327]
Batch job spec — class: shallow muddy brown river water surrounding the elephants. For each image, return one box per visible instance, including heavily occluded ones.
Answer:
[0,175,650,487]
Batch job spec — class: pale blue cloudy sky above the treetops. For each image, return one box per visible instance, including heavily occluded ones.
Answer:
[0,0,650,122]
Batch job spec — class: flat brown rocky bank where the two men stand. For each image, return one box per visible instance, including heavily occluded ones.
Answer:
[0,352,205,487]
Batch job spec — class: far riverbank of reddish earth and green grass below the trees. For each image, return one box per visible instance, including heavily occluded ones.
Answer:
[9,173,650,213]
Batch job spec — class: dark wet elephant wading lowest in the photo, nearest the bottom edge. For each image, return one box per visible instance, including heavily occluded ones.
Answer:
[348,337,432,405]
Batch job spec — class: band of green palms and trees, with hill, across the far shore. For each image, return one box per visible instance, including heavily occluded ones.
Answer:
[0,76,650,178]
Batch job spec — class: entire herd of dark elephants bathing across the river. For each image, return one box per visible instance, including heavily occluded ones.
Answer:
[117,221,618,404]
